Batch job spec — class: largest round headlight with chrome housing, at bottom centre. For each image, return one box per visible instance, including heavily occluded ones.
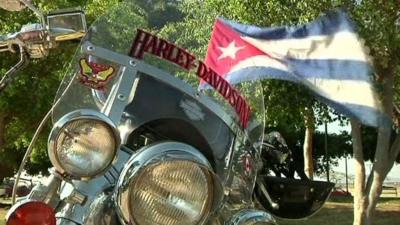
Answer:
[115,142,223,225]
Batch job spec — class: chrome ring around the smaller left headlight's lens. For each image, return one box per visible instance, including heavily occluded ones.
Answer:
[48,109,121,180]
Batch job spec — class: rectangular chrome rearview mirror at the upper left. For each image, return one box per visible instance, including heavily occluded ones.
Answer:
[46,10,87,41]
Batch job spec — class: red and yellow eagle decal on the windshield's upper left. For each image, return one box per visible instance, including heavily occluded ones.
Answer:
[78,58,115,90]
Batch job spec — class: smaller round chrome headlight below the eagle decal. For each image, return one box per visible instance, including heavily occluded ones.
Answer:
[48,110,120,180]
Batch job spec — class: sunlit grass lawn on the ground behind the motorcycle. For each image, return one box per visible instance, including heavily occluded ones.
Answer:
[0,198,400,225]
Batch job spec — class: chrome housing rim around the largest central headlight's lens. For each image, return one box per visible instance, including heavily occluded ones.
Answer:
[114,142,223,225]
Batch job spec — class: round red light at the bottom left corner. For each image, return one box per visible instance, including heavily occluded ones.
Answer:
[7,201,56,225]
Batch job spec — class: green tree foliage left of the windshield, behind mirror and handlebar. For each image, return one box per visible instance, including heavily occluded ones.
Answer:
[0,0,120,173]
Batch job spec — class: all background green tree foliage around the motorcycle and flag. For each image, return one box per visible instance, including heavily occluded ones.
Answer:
[0,0,400,175]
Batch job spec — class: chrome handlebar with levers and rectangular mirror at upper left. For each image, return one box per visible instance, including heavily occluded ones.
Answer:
[0,5,87,94]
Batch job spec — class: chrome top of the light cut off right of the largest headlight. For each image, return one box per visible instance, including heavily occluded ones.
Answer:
[226,209,277,225]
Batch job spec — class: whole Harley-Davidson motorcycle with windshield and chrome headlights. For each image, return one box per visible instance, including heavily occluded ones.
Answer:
[0,0,333,225]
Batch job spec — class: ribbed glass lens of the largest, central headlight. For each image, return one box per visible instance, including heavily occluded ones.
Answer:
[129,161,212,225]
